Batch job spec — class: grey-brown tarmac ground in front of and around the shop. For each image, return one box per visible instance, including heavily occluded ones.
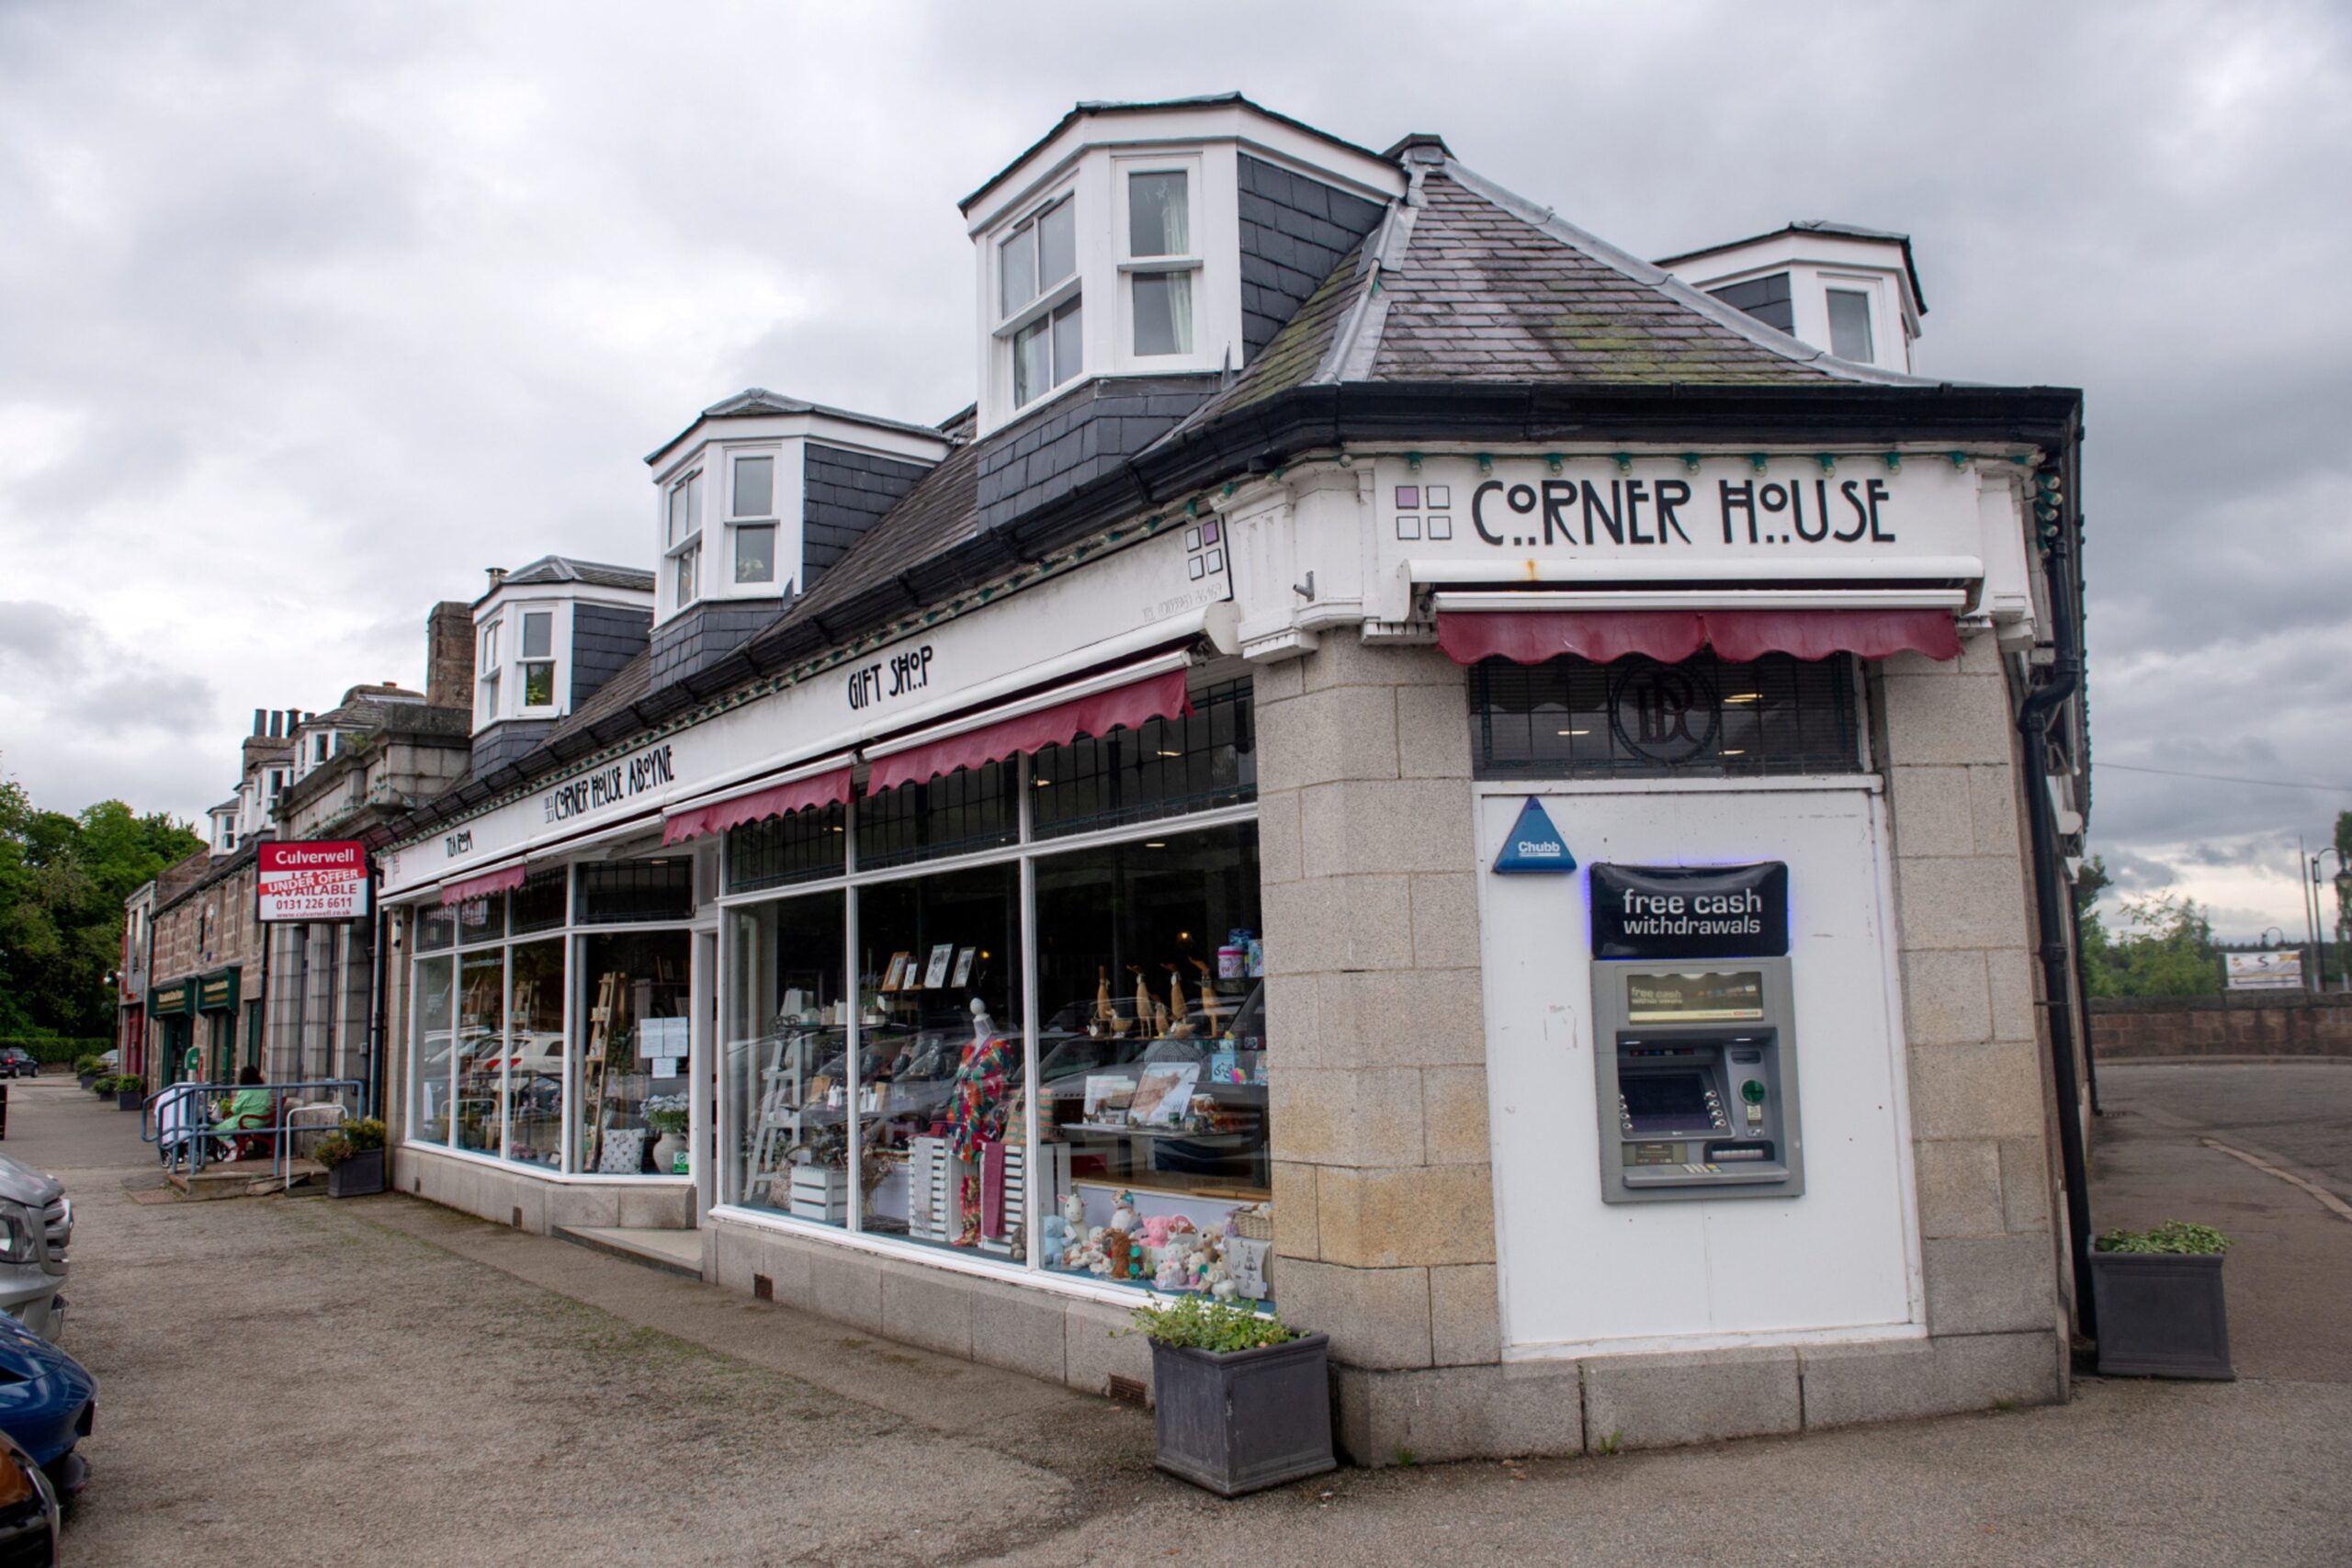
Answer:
[0,1067,2352,1568]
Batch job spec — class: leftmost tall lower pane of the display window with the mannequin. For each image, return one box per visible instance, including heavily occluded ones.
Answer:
[719,891,860,1224]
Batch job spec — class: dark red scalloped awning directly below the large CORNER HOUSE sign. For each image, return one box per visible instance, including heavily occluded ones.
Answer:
[1437,609,1959,665]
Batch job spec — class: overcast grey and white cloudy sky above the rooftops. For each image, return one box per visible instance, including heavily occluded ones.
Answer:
[0,0,2352,936]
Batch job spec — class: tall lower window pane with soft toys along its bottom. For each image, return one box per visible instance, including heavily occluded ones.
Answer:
[1035,825,1272,1300]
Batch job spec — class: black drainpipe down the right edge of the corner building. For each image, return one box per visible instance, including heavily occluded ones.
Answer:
[2018,453,2098,1340]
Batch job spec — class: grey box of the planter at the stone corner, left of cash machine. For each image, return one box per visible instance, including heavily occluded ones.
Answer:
[1152,1333,1336,1497]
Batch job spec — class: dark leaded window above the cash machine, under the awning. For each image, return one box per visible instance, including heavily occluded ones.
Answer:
[1470,653,1863,778]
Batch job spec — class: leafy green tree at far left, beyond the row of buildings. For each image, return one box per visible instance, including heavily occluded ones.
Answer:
[0,781,202,1037]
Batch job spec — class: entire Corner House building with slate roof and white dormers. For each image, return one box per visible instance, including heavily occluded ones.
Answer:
[381,96,2088,1462]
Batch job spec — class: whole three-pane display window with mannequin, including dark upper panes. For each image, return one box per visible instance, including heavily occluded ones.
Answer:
[719,682,1275,1303]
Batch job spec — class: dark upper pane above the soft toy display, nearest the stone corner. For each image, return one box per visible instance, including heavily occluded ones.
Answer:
[1028,682,1259,837]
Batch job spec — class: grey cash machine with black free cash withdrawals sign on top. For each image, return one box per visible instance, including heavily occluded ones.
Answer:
[1592,863,1804,1203]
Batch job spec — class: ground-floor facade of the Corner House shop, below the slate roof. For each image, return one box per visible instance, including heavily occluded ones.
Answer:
[371,116,2086,1462]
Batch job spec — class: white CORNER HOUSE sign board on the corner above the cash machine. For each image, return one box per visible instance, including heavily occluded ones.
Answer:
[1376,454,1983,581]
